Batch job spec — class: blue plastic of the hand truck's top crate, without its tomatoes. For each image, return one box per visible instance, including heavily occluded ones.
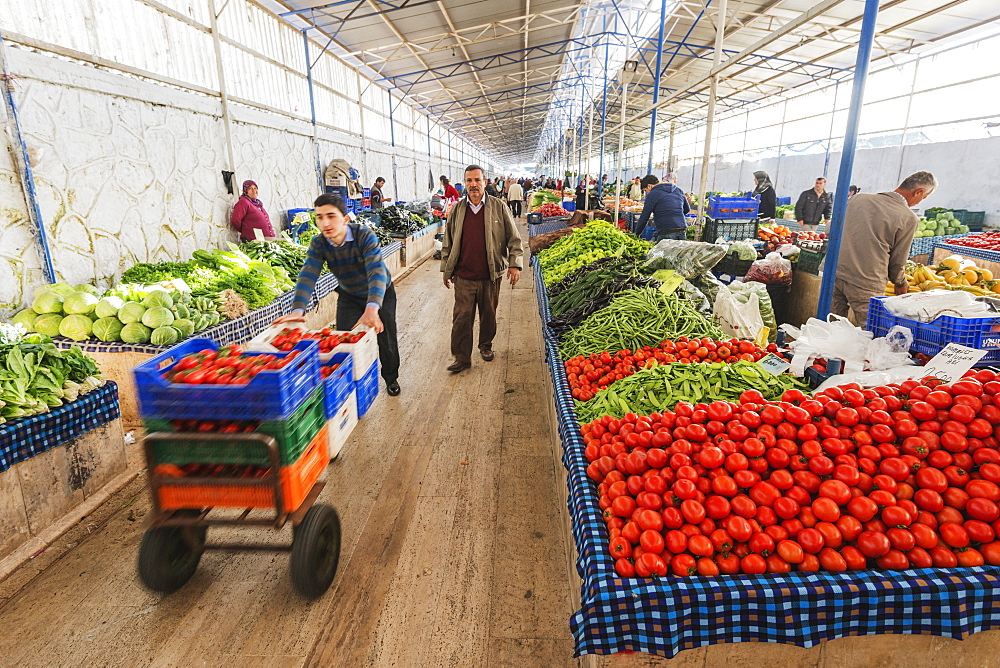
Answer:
[132,338,320,420]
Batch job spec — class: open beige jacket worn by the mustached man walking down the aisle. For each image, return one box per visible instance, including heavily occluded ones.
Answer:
[441,195,524,280]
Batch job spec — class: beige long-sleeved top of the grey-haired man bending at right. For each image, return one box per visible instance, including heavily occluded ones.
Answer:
[837,192,918,294]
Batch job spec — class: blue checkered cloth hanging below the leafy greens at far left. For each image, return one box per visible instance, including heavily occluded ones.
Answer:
[0,381,119,472]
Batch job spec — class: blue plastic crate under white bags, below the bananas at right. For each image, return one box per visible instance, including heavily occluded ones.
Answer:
[867,297,1000,364]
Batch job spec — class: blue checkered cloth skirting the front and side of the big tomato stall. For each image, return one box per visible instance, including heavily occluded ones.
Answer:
[534,264,1000,657]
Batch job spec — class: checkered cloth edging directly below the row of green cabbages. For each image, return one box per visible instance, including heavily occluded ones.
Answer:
[53,273,338,355]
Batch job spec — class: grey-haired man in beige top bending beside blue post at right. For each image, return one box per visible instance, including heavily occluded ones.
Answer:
[830,172,937,327]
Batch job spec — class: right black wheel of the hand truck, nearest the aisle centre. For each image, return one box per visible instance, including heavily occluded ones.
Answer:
[291,503,340,598]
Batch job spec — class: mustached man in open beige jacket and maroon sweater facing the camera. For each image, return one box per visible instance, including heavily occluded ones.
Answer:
[441,165,522,373]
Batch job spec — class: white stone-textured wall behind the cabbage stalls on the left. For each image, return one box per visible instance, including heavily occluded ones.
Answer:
[0,47,462,315]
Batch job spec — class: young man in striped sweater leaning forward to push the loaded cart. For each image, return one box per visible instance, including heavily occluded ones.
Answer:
[274,194,400,397]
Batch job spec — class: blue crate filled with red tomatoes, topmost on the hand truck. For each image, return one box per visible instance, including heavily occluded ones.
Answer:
[132,338,320,420]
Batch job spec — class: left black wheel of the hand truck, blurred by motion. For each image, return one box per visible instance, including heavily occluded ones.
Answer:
[139,510,208,594]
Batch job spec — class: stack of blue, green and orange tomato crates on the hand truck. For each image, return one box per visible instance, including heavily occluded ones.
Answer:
[134,339,330,512]
